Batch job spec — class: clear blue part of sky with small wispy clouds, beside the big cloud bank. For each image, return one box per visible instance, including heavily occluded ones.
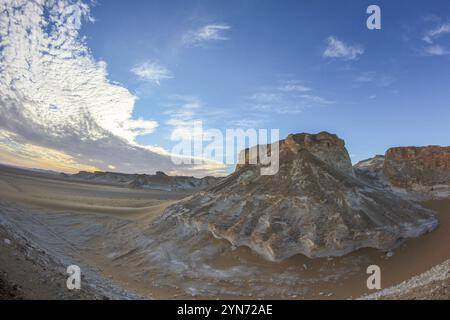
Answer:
[0,0,450,175]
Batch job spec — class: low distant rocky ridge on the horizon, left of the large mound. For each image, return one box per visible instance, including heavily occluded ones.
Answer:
[66,171,220,191]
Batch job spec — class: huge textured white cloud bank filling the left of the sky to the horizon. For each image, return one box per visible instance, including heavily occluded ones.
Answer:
[0,0,218,175]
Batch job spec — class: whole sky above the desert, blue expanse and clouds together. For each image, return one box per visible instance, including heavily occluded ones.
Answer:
[0,0,450,176]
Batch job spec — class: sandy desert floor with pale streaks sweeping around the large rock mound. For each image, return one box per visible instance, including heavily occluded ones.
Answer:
[0,168,450,299]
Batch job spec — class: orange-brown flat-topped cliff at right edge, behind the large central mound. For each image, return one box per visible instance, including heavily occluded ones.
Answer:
[383,146,450,189]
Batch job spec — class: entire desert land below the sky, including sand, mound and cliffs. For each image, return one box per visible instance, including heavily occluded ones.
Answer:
[0,132,450,299]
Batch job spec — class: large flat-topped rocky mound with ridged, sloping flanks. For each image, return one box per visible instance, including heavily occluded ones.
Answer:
[156,132,437,260]
